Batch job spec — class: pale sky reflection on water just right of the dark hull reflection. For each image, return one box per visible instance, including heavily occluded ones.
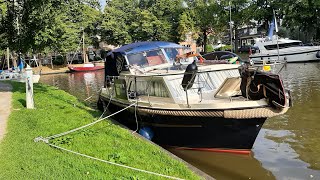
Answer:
[253,129,320,179]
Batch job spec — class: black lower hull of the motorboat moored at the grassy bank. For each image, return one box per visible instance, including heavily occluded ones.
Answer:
[101,99,266,150]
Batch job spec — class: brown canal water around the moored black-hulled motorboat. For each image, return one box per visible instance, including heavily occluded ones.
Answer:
[40,63,320,180]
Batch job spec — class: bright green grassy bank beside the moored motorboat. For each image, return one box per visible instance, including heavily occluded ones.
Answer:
[0,83,199,179]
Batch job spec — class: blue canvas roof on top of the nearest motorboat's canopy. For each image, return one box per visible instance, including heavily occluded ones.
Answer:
[108,41,186,55]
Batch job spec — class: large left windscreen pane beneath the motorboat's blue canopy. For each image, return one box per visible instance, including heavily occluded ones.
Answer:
[128,50,167,67]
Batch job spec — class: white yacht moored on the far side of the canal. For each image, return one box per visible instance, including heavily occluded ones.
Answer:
[249,35,320,62]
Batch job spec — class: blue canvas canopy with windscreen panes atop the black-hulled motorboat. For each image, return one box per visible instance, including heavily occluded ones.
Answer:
[105,41,196,79]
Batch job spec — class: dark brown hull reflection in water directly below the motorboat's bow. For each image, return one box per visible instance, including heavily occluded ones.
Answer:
[169,149,275,180]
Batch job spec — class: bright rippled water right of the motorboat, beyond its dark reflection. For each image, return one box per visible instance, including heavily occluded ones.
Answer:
[254,63,320,179]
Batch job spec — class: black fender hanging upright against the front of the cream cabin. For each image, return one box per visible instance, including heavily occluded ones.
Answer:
[181,60,198,91]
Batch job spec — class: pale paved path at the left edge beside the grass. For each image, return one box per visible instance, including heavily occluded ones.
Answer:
[0,82,12,141]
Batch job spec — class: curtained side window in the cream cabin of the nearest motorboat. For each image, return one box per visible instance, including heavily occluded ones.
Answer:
[129,79,169,97]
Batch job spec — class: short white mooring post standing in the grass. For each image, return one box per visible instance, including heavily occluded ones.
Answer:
[26,65,34,109]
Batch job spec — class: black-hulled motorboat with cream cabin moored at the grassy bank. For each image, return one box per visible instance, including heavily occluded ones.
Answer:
[98,41,290,150]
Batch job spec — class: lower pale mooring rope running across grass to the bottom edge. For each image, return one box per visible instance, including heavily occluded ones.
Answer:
[48,143,182,180]
